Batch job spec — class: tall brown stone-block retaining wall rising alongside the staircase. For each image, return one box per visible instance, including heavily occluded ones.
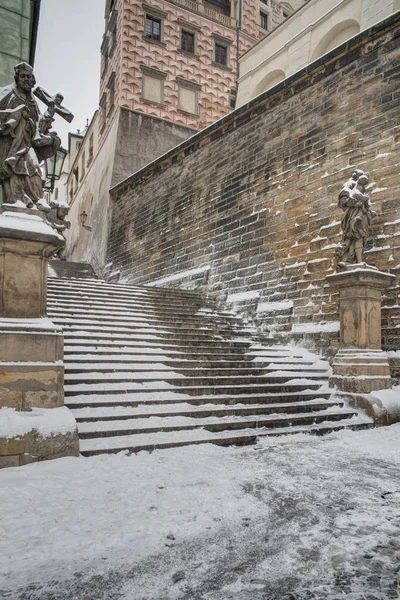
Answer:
[108,15,400,350]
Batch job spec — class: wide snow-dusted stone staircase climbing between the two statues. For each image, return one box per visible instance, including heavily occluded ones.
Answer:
[48,277,371,456]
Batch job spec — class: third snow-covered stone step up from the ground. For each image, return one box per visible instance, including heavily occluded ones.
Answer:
[72,395,343,424]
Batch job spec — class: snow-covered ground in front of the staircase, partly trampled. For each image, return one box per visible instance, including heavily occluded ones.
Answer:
[0,424,400,600]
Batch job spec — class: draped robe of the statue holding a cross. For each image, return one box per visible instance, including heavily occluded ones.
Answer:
[0,85,60,206]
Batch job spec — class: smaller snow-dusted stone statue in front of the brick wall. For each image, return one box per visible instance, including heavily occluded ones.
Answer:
[335,169,376,271]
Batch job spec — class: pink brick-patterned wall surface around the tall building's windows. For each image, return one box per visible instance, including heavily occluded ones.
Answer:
[100,0,290,145]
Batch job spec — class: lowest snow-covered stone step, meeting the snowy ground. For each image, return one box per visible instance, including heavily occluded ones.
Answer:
[81,417,371,456]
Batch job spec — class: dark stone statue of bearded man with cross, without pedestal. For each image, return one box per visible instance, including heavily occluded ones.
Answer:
[0,62,73,212]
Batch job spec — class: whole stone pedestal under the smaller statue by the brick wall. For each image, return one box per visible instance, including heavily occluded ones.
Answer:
[327,265,395,394]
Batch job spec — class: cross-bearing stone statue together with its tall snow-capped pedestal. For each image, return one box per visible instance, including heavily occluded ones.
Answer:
[0,63,79,468]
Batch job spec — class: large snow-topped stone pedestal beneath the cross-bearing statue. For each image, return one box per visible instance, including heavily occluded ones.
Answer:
[0,205,79,467]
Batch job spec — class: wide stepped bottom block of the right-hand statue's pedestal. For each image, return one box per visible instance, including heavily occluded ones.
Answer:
[329,348,392,394]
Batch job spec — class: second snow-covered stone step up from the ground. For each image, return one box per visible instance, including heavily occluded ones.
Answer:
[78,407,355,439]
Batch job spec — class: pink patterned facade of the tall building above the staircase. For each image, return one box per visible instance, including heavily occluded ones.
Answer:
[100,0,294,138]
